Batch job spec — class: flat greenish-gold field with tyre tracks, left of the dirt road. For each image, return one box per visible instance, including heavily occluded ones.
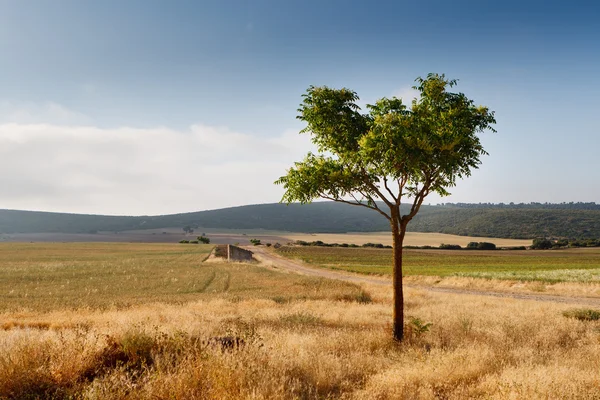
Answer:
[0,243,360,312]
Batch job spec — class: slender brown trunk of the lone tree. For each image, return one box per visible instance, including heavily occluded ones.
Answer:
[391,215,406,342]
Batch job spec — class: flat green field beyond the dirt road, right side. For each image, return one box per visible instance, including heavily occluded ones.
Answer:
[277,246,600,282]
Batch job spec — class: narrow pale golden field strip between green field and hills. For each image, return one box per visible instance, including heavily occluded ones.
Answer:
[280,232,531,247]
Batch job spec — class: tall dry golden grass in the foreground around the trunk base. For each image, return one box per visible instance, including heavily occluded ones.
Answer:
[0,282,600,399]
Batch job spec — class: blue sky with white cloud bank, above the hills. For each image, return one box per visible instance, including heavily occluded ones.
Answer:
[0,0,600,214]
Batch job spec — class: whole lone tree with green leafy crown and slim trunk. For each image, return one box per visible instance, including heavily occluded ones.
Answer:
[275,74,496,341]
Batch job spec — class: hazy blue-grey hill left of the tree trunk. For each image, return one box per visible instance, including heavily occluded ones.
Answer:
[0,202,389,233]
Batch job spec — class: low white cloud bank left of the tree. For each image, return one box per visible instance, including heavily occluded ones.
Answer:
[0,123,312,215]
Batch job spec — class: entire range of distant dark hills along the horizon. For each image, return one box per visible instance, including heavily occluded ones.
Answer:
[0,202,600,239]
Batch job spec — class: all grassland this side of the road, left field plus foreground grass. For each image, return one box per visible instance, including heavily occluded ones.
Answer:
[0,244,600,399]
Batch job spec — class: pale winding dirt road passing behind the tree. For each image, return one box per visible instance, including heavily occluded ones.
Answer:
[248,247,600,307]
